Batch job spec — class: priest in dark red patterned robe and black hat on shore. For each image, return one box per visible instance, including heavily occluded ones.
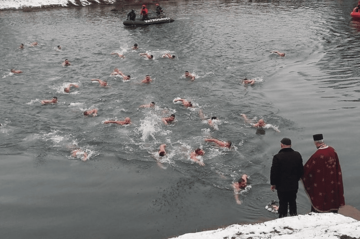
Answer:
[302,134,345,213]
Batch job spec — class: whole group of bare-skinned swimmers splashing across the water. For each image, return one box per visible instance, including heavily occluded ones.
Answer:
[11,34,285,204]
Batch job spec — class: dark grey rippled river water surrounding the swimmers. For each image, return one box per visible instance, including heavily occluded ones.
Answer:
[0,0,360,239]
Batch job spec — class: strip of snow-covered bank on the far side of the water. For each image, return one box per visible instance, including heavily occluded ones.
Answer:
[0,0,116,10]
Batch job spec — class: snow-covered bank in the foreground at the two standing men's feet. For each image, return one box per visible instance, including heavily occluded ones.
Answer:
[174,213,360,239]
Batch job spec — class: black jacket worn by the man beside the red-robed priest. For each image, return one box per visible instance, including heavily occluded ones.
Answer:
[270,148,304,192]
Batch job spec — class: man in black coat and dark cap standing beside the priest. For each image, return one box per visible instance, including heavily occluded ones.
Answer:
[270,138,304,218]
